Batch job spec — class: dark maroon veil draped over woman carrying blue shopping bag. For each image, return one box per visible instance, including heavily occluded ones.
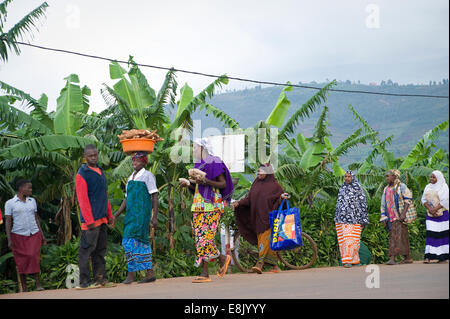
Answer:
[234,164,283,245]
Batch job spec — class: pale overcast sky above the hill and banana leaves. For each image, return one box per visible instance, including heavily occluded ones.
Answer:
[0,0,449,112]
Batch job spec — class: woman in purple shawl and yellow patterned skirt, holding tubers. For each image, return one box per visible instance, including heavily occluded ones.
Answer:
[180,139,234,283]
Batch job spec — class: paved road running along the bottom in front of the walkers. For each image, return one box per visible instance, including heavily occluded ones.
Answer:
[0,262,449,299]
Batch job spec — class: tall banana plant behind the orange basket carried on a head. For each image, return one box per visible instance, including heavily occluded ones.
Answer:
[101,57,239,248]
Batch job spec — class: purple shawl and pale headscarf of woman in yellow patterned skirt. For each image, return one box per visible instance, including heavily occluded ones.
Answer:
[194,138,234,204]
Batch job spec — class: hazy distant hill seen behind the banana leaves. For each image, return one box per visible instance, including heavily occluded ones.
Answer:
[193,80,449,165]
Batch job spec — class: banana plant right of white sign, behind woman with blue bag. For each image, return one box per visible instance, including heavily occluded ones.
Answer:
[266,81,377,206]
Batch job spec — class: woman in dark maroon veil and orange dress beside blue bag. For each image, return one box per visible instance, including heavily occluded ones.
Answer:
[233,164,289,274]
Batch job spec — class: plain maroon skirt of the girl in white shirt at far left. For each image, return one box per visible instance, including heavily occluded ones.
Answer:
[11,231,42,274]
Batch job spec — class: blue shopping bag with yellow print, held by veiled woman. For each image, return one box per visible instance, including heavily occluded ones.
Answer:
[269,199,303,250]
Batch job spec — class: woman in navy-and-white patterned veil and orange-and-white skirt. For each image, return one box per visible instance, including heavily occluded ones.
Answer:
[334,171,369,268]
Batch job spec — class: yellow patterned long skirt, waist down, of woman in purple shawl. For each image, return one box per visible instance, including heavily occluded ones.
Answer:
[193,211,220,267]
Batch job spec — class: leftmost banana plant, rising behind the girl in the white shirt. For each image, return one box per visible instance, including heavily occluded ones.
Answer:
[0,74,110,244]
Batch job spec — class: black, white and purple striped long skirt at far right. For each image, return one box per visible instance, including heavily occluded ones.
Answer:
[424,210,448,261]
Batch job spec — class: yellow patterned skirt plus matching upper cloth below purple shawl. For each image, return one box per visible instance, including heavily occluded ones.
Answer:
[191,185,224,267]
